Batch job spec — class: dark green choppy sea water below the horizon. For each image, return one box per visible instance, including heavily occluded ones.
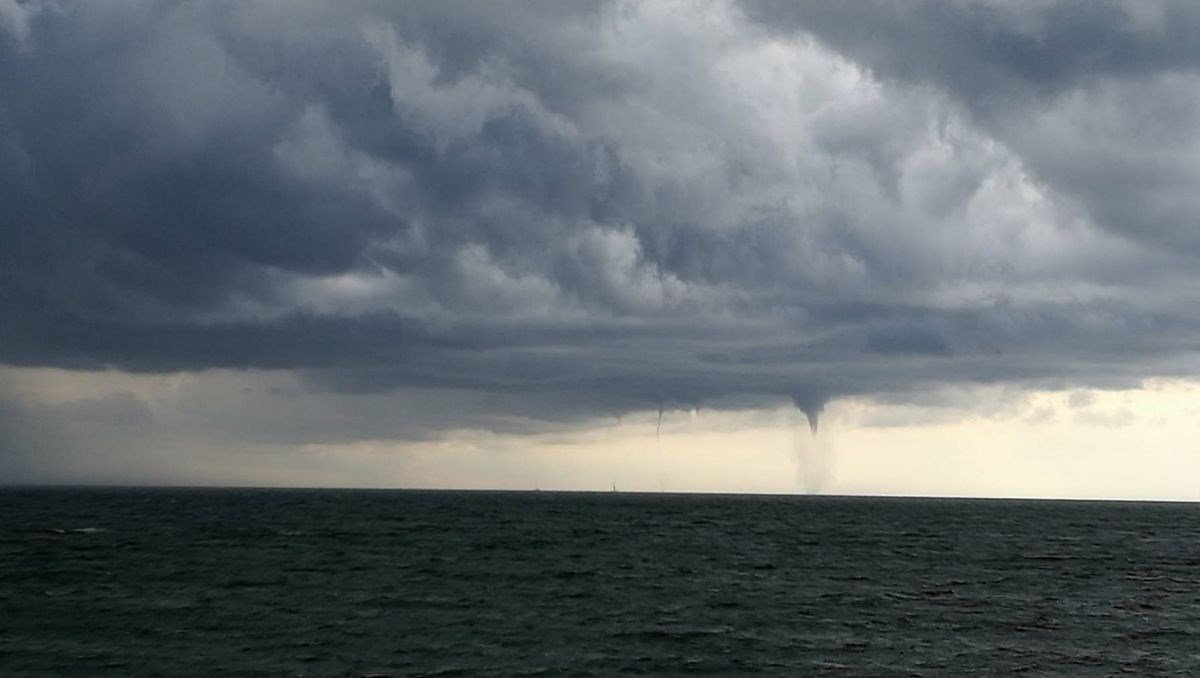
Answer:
[0,488,1200,676]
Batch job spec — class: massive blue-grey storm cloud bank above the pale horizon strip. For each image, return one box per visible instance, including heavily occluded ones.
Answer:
[0,2,1200,434]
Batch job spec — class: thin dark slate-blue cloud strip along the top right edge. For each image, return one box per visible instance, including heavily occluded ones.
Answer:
[743,0,1200,105]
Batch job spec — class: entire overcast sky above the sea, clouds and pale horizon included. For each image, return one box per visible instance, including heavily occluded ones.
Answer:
[0,0,1200,497]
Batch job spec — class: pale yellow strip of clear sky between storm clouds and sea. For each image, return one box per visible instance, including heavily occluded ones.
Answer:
[6,370,1200,500]
